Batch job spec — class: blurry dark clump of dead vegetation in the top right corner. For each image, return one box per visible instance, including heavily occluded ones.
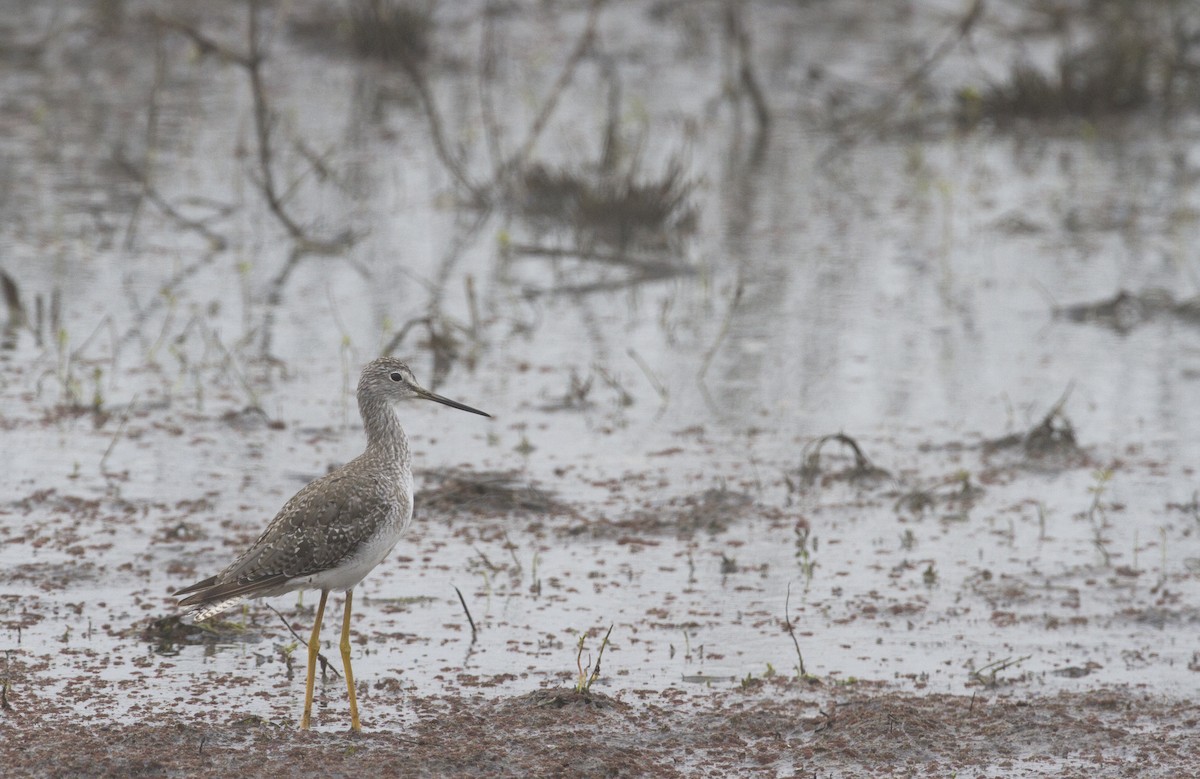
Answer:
[821,0,1200,153]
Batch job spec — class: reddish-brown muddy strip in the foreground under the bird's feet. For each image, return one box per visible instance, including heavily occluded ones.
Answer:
[0,684,1196,777]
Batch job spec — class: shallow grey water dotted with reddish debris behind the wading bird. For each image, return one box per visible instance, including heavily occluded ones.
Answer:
[0,4,1200,725]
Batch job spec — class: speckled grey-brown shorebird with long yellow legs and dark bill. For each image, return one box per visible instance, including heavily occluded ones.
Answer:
[175,356,490,730]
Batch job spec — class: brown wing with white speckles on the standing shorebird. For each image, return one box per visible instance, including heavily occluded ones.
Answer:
[180,471,395,613]
